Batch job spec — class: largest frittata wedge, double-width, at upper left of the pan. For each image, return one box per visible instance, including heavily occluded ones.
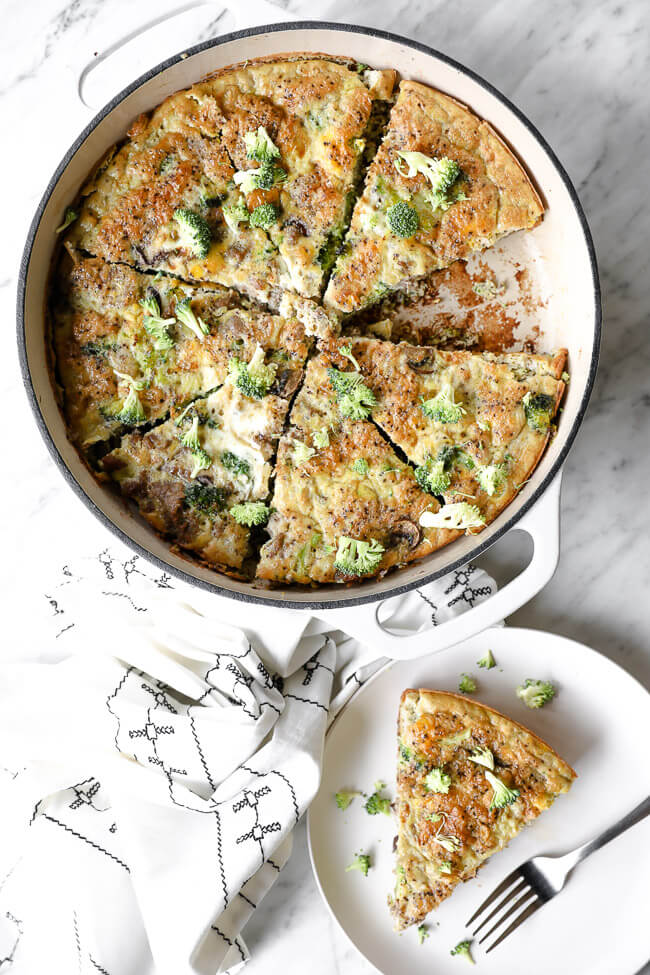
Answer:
[68,56,395,307]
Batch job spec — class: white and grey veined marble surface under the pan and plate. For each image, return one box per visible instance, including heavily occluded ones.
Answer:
[0,0,650,975]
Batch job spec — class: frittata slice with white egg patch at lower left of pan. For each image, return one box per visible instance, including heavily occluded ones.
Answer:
[102,364,302,577]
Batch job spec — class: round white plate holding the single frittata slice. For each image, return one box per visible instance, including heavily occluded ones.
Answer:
[309,627,650,975]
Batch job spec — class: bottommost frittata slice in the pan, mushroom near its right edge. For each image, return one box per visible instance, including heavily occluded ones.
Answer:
[257,346,458,584]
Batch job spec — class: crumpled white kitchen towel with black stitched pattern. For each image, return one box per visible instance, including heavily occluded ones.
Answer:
[0,544,496,975]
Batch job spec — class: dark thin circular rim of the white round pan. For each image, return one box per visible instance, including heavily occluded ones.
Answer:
[16,20,602,611]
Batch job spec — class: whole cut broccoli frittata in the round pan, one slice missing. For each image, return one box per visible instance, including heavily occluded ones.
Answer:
[50,54,566,586]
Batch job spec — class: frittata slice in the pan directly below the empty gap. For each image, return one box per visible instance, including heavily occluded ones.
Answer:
[330,338,566,531]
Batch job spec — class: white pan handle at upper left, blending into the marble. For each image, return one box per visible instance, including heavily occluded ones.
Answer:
[77,0,296,112]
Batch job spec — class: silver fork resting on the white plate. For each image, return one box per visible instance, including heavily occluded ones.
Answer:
[466,796,650,953]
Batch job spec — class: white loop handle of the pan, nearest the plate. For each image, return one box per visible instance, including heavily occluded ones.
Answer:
[315,472,562,660]
